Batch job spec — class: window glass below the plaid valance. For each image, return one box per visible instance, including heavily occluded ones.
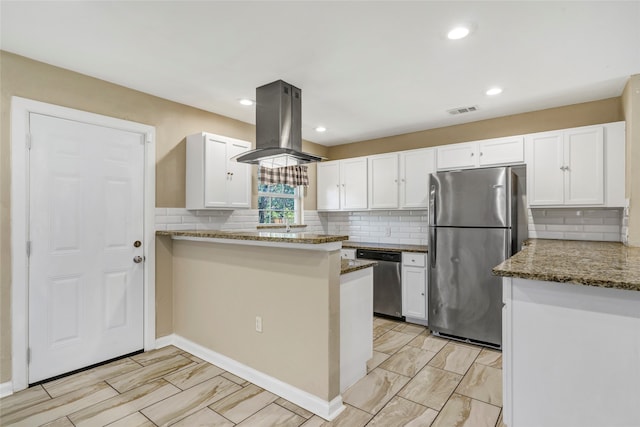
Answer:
[258,184,302,224]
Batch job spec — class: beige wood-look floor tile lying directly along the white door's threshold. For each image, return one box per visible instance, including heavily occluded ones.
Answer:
[42,357,142,397]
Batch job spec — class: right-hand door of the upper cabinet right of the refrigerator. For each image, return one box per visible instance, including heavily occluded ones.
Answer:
[563,126,604,205]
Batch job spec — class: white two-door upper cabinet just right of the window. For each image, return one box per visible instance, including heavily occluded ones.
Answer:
[317,157,367,211]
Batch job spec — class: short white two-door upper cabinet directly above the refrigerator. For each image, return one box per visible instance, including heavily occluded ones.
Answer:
[437,136,524,170]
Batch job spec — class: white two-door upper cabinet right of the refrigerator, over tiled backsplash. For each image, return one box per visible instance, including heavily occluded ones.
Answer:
[526,122,625,207]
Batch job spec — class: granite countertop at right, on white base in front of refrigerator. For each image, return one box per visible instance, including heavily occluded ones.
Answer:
[493,239,640,291]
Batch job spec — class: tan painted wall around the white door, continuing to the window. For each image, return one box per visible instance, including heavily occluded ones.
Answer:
[0,51,327,383]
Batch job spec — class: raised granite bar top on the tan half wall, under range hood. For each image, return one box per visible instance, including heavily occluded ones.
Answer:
[156,230,349,244]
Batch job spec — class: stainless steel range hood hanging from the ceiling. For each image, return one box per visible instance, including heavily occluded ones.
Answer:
[235,80,322,166]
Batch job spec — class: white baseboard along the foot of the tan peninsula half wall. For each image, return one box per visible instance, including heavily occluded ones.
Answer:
[156,334,344,421]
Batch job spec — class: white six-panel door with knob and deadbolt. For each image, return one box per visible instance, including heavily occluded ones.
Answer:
[28,113,145,383]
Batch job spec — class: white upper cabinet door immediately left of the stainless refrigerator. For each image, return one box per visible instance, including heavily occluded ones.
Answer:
[400,148,436,208]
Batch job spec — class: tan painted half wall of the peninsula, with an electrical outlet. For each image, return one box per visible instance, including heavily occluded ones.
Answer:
[173,240,340,401]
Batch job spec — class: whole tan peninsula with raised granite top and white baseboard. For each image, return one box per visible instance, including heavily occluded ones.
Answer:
[156,230,373,419]
